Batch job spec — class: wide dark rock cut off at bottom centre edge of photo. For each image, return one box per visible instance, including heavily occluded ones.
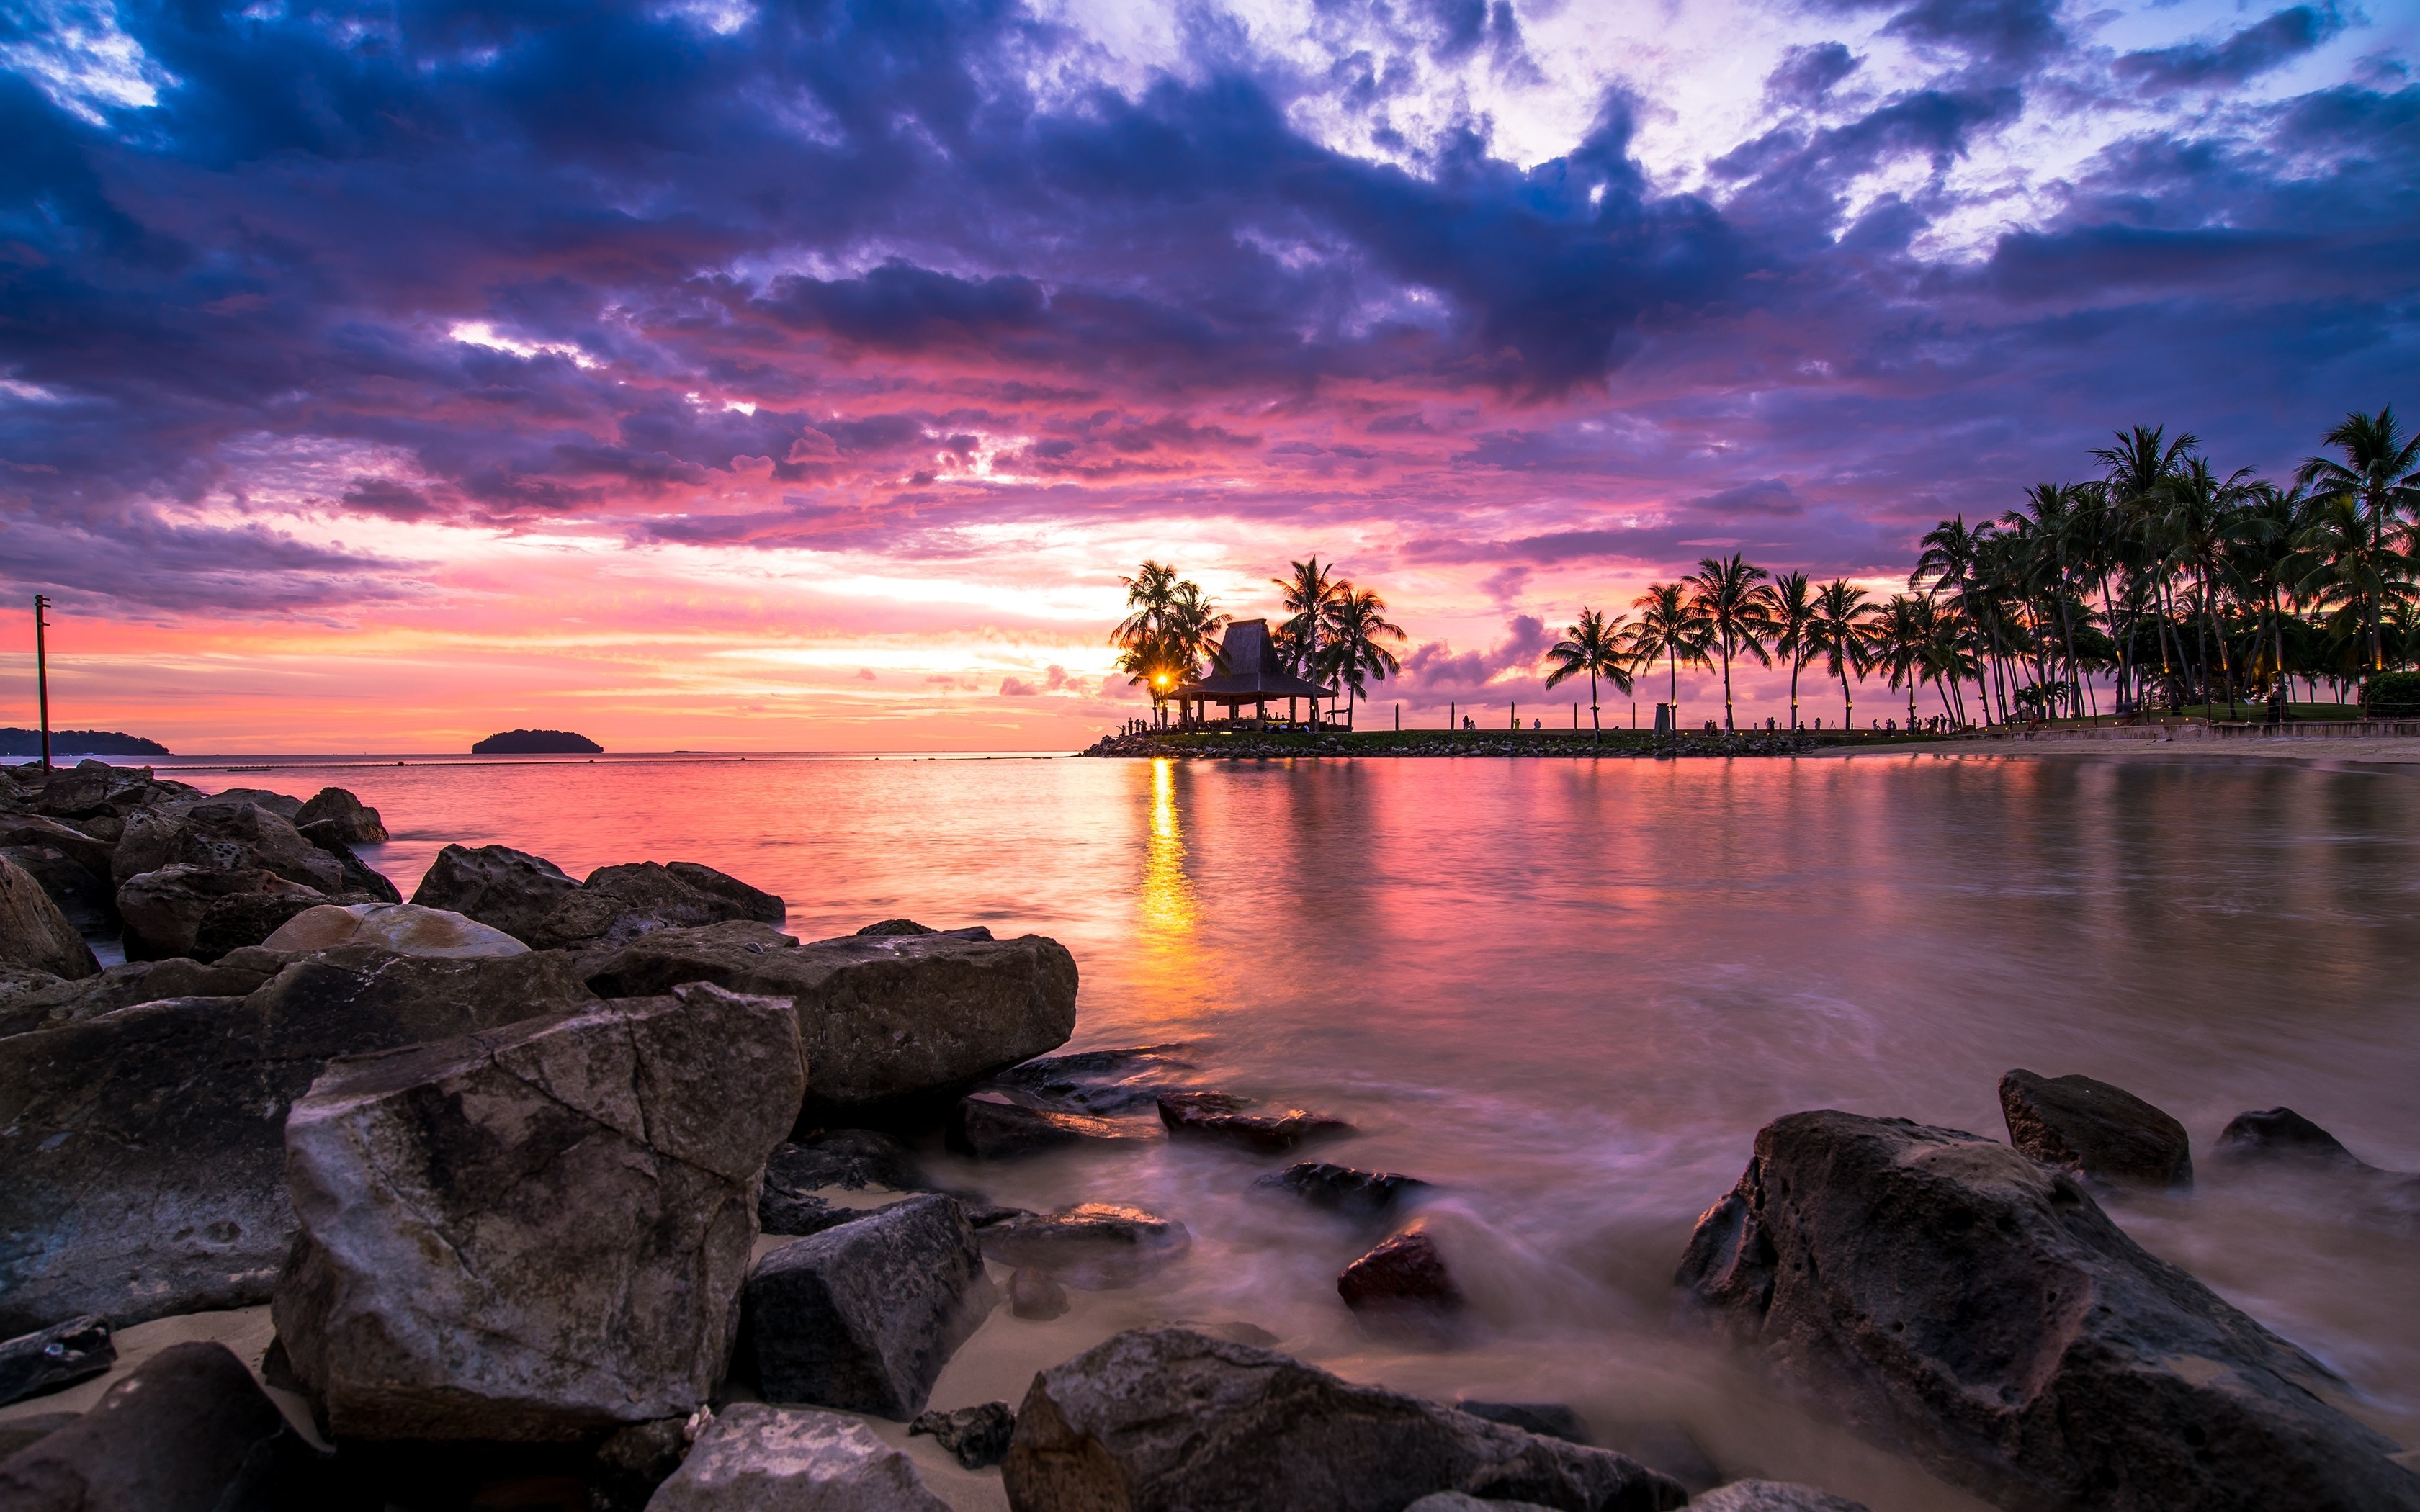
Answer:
[1002,1328,1687,1512]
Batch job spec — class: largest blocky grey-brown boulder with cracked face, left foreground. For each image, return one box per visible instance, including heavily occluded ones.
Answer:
[274,985,803,1442]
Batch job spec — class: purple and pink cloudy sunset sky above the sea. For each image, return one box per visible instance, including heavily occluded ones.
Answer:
[0,0,2420,752]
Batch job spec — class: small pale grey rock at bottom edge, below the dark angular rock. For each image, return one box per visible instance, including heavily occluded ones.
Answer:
[646,1400,949,1512]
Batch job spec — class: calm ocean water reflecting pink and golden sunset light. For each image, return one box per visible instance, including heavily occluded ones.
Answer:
[191,755,2420,1512]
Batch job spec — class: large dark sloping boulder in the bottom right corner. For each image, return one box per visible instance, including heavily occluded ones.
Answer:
[1677,1113,2420,1512]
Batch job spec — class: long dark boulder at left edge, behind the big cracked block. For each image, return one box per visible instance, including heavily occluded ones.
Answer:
[0,946,593,1333]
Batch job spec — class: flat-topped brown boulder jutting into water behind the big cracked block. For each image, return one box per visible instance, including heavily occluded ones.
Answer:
[588,922,1077,1125]
